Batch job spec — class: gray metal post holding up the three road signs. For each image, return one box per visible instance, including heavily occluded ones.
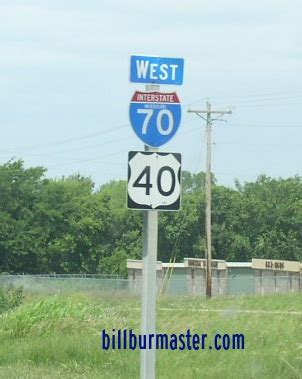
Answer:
[141,85,159,379]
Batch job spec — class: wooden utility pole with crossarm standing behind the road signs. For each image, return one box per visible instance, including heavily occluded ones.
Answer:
[188,102,232,298]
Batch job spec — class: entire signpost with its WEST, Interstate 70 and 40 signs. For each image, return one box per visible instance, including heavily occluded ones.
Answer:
[128,55,184,379]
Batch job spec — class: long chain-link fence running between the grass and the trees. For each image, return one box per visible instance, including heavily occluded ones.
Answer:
[0,275,302,296]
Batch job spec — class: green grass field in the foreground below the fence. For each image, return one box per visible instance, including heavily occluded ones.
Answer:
[0,294,302,379]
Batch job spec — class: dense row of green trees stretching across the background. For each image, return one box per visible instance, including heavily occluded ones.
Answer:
[0,160,302,275]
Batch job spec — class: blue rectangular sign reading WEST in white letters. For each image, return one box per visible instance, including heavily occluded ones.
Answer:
[130,55,184,85]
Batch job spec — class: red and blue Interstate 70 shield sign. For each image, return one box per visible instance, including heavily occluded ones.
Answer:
[130,91,181,147]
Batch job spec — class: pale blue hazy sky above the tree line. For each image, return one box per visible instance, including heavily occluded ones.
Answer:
[0,0,302,187]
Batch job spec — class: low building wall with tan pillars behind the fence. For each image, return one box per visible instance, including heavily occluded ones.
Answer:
[128,264,302,296]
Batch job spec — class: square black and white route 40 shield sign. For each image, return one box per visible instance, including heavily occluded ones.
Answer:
[127,151,181,211]
